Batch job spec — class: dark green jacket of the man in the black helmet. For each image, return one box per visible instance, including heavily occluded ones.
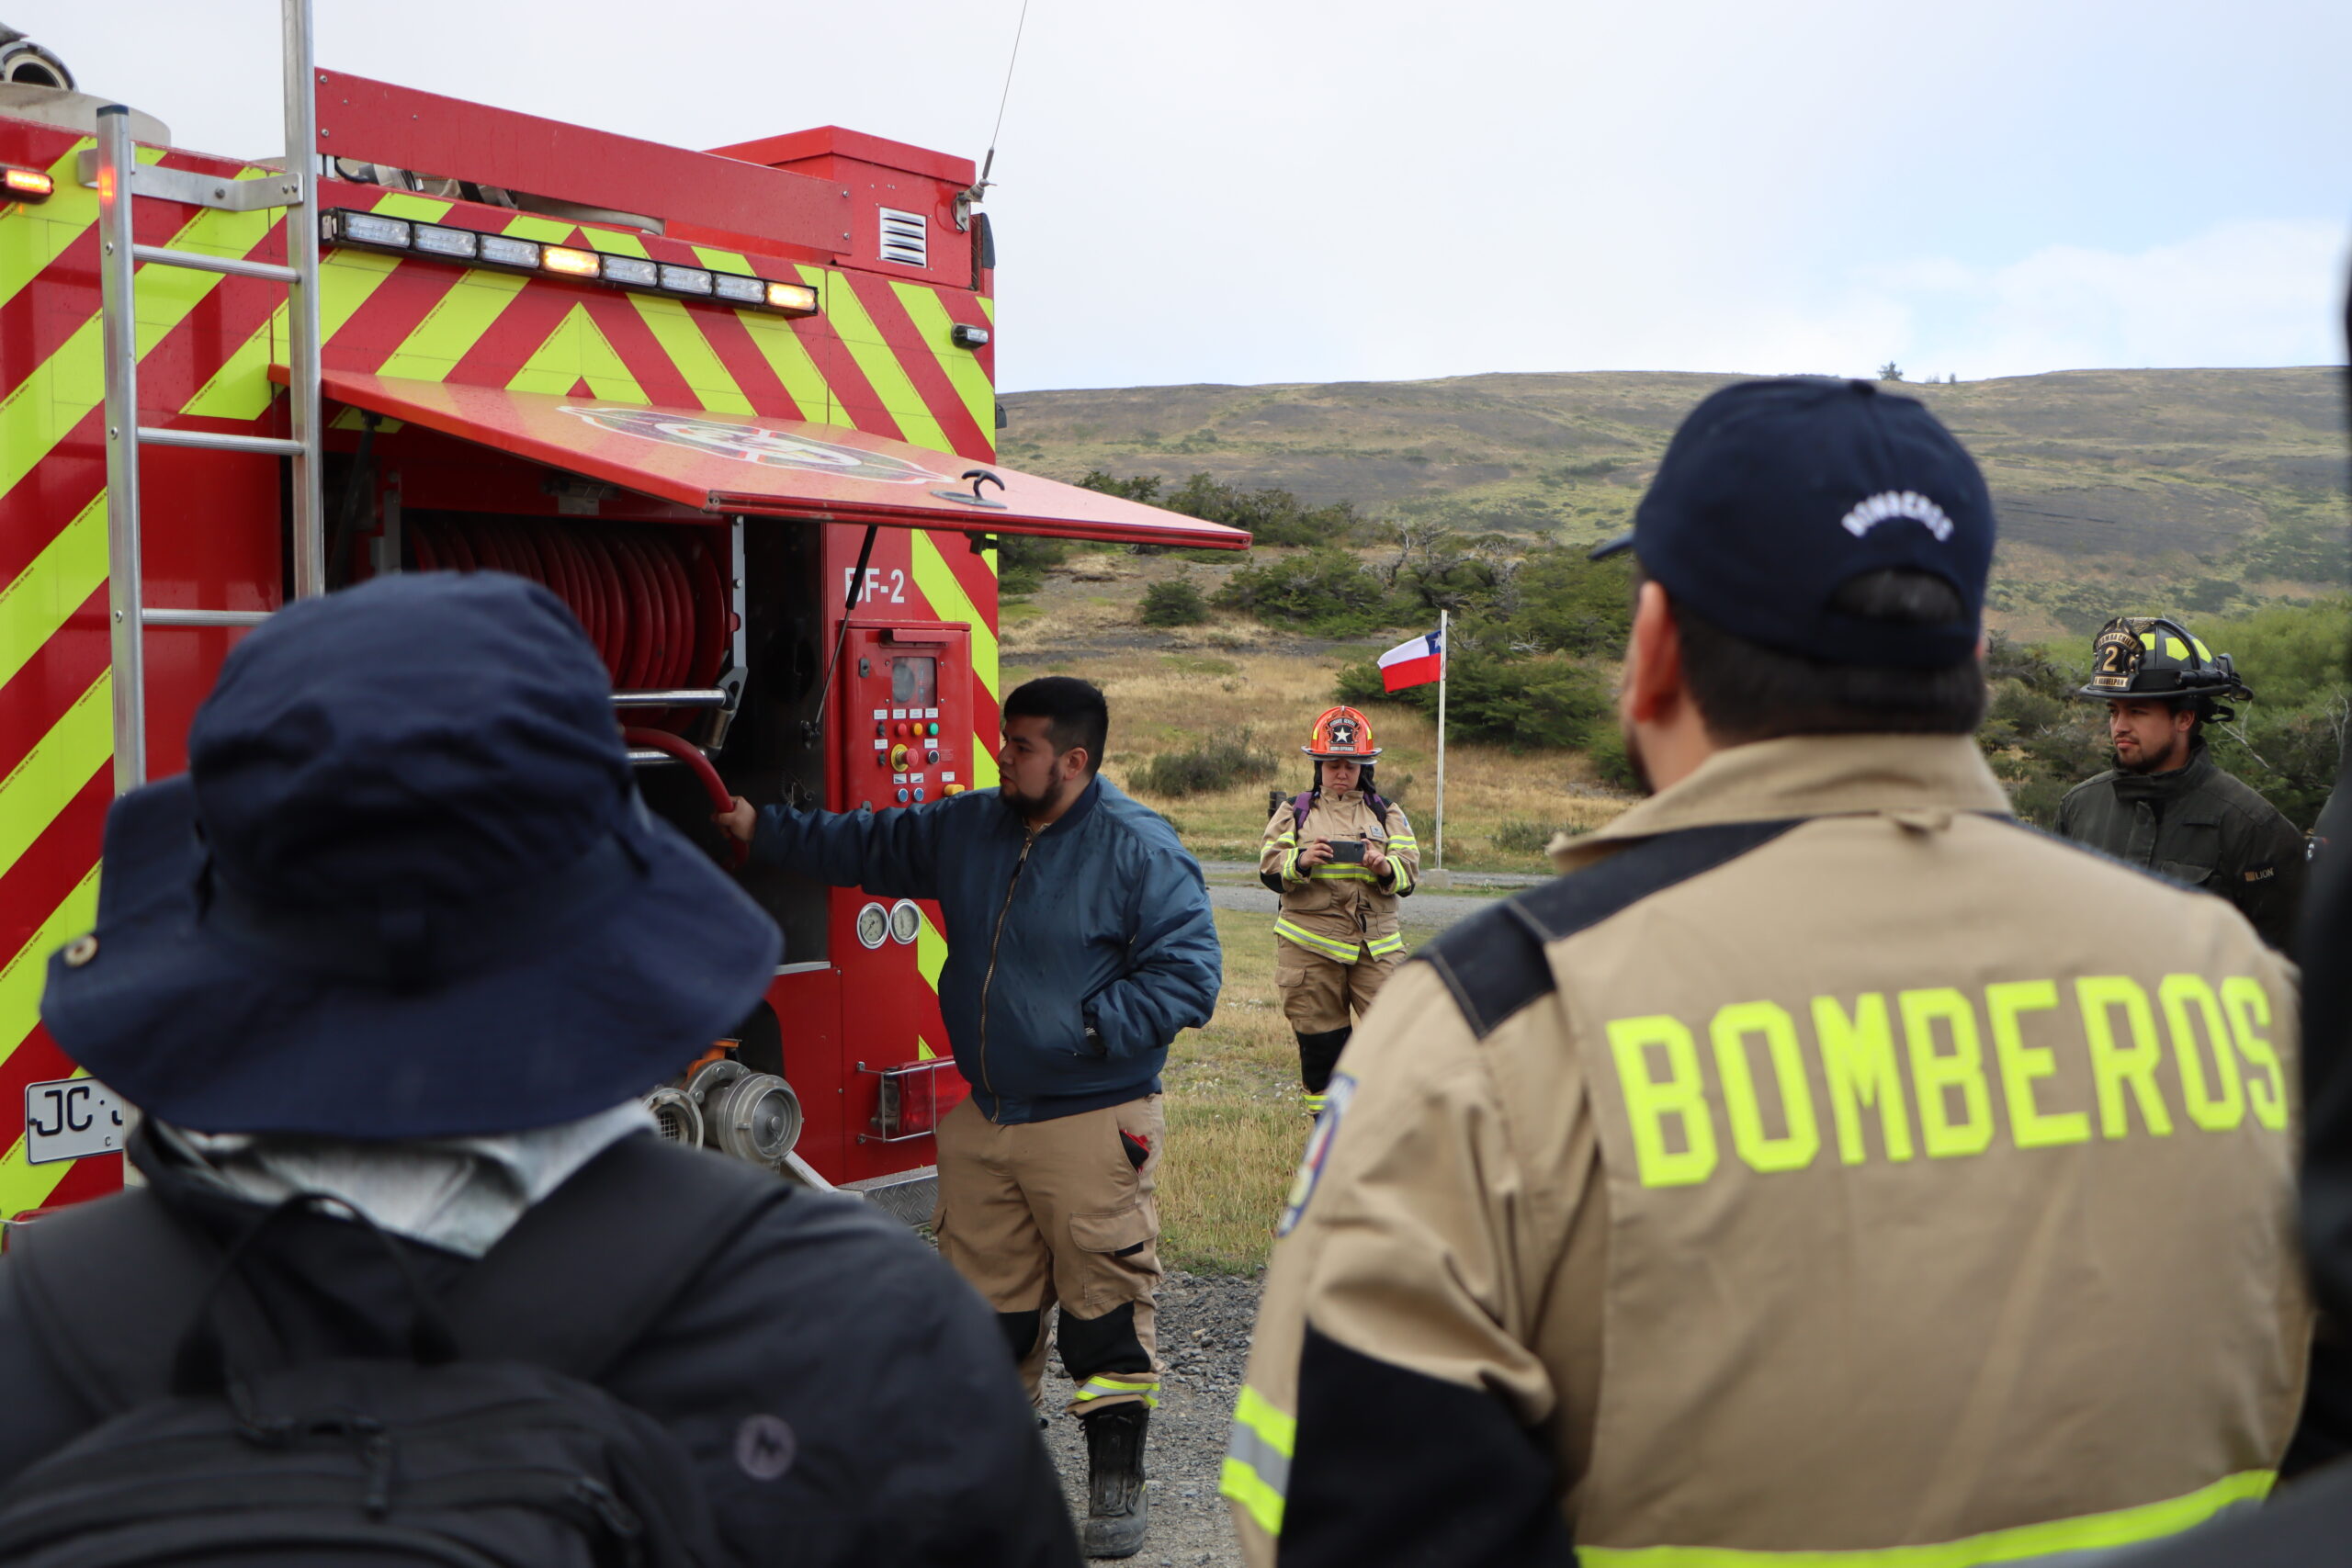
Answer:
[2058,745,2305,952]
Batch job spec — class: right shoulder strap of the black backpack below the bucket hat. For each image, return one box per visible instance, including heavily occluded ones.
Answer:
[447,1135,795,1382]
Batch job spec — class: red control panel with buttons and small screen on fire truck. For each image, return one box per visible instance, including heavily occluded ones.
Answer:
[842,623,978,811]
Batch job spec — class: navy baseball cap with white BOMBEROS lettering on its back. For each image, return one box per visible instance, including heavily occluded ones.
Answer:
[1592,376,1992,670]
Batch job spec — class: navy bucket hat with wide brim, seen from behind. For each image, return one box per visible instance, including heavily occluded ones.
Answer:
[40,571,783,1138]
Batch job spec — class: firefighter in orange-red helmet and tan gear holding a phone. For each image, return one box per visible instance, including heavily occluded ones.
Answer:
[1259,707,1420,1112]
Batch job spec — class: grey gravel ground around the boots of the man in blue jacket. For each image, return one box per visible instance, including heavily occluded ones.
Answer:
[1045,1274,1259,1568]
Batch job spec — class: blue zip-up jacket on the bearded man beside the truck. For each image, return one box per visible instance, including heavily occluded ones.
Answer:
[751,776,1223,1123]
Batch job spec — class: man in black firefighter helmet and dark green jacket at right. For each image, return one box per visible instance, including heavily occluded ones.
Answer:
[2058,616,2305,952]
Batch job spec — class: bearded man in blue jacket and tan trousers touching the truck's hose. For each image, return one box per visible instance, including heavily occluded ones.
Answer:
[719,674,1223,1556]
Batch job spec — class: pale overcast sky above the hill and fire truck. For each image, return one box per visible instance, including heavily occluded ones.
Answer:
[37,0,2352,390]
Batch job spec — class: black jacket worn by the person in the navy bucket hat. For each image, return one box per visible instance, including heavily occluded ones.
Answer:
[0,1140,1080,1568]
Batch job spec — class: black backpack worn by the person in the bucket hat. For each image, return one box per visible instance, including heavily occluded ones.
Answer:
[0,1138,790,1568]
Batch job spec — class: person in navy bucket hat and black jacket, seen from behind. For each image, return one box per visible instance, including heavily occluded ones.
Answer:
[0,573,1077,1568]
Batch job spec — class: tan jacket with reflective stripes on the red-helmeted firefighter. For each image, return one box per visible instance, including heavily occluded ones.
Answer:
[1259,790,1420,964]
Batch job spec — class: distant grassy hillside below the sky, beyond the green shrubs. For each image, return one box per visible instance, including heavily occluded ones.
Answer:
[1004,369,2347,639]
